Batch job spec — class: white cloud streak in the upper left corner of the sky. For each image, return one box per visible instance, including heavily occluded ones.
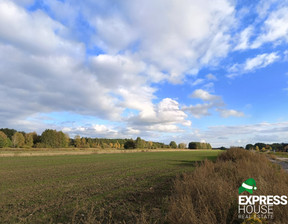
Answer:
[0,0,84,57]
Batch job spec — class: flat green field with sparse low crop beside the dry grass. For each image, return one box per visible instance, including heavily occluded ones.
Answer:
[0,150,219,223]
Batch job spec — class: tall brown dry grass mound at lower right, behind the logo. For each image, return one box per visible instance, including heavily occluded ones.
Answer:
[168,148,288,224]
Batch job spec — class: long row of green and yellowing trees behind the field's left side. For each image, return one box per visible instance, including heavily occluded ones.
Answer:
[0,128,212,149]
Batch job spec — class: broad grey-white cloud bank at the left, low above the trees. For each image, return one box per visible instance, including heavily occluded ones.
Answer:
[0,45,122,122]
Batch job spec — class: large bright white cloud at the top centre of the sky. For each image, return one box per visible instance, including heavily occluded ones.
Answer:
[80,0,234,83]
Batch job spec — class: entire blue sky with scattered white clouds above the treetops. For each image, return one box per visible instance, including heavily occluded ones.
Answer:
[0,0,288,147]
